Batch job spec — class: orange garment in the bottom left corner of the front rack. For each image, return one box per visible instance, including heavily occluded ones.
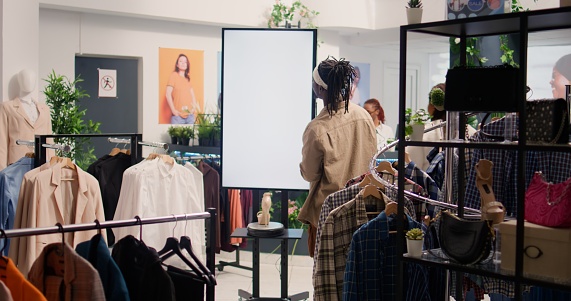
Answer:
[0,257,46,301]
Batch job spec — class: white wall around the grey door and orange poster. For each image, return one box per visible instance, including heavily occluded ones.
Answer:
[39,9,222,142]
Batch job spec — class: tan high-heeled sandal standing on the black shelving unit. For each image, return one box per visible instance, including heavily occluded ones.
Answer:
[476,159,506,224]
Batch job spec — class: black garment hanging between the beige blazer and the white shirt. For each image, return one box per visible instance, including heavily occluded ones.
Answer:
[87,153,131,246]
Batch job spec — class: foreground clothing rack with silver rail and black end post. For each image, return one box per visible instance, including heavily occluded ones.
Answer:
[2,208,216,301]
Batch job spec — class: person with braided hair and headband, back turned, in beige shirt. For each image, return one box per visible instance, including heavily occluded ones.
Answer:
[298,57,377,256]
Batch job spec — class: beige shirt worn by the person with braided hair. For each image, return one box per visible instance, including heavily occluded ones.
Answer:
[298,103,377,228]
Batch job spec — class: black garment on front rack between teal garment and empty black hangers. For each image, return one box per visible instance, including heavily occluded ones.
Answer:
[111,234,176,301]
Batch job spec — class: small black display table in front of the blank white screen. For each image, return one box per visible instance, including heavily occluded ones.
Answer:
[230,228,309,301]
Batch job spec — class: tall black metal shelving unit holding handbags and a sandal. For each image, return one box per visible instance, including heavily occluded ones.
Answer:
[397,7,571,300]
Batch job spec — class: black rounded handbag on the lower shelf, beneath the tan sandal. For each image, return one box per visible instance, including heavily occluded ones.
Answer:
[431,210,495,264]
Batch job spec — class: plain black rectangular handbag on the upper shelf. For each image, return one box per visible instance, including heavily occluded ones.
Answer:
[444,65,520,112]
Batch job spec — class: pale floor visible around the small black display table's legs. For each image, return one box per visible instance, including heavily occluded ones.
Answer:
[216,251,313,301]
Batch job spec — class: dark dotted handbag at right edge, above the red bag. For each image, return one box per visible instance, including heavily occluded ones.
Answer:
[525,98,569,144]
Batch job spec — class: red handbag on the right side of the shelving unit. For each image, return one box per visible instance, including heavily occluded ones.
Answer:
[525,171,571,228]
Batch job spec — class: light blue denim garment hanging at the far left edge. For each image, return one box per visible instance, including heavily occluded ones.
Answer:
[0,157,34,255]
